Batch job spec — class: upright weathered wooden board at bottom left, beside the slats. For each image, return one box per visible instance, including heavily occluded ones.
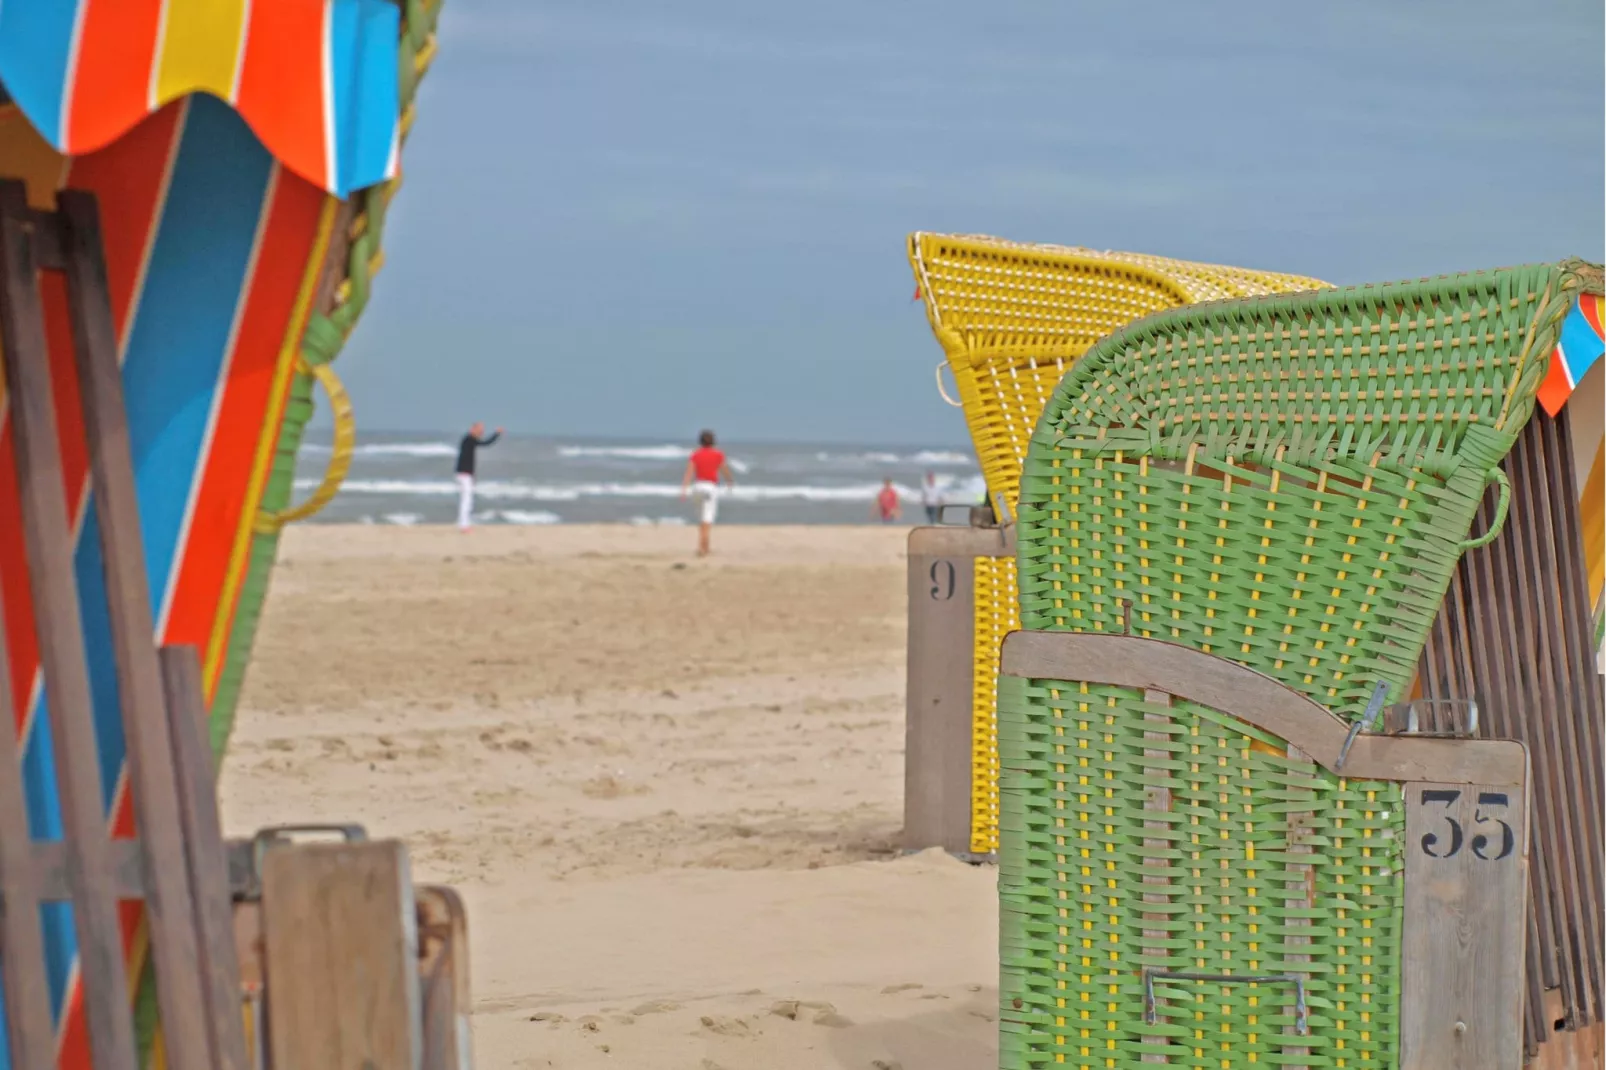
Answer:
[259,840,422,1070]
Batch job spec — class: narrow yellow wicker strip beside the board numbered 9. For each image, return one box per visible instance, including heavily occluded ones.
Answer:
[970,557,1020,855]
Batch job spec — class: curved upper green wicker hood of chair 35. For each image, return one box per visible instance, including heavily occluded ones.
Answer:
[1018,257,1582,712]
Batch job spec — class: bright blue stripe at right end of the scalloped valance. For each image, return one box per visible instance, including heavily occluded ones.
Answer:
[329,0,402,198]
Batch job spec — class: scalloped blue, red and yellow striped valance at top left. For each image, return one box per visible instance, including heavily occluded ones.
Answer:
[0,0,400,198]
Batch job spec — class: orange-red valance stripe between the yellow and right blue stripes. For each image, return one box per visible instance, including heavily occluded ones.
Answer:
[236,0,329,186]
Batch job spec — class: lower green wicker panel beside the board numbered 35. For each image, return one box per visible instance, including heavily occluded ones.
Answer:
[999,678,1404,1070]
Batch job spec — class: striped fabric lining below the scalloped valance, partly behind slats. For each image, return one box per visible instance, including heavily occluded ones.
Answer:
[0,95,330,1070]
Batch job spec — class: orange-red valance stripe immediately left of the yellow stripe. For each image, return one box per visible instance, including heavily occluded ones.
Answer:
[66,0,162,156]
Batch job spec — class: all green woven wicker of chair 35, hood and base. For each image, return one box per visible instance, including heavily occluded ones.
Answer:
[999,262,1600,1070]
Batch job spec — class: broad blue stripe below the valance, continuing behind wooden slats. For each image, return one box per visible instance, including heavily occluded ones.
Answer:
[0,95,273,1041]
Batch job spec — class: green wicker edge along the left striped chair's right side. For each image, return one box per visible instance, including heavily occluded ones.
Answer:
[135,0,443,1067]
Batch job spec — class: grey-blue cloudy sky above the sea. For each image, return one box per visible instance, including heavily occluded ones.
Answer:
[337,0,1606,443]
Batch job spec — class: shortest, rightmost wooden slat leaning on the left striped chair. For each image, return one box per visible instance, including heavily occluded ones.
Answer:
[161,646,251,1070]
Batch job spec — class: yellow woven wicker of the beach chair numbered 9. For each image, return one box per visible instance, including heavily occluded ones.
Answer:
[909,233,1327,855]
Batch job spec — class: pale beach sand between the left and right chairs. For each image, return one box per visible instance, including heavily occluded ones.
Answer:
[222,527,997,1070]
